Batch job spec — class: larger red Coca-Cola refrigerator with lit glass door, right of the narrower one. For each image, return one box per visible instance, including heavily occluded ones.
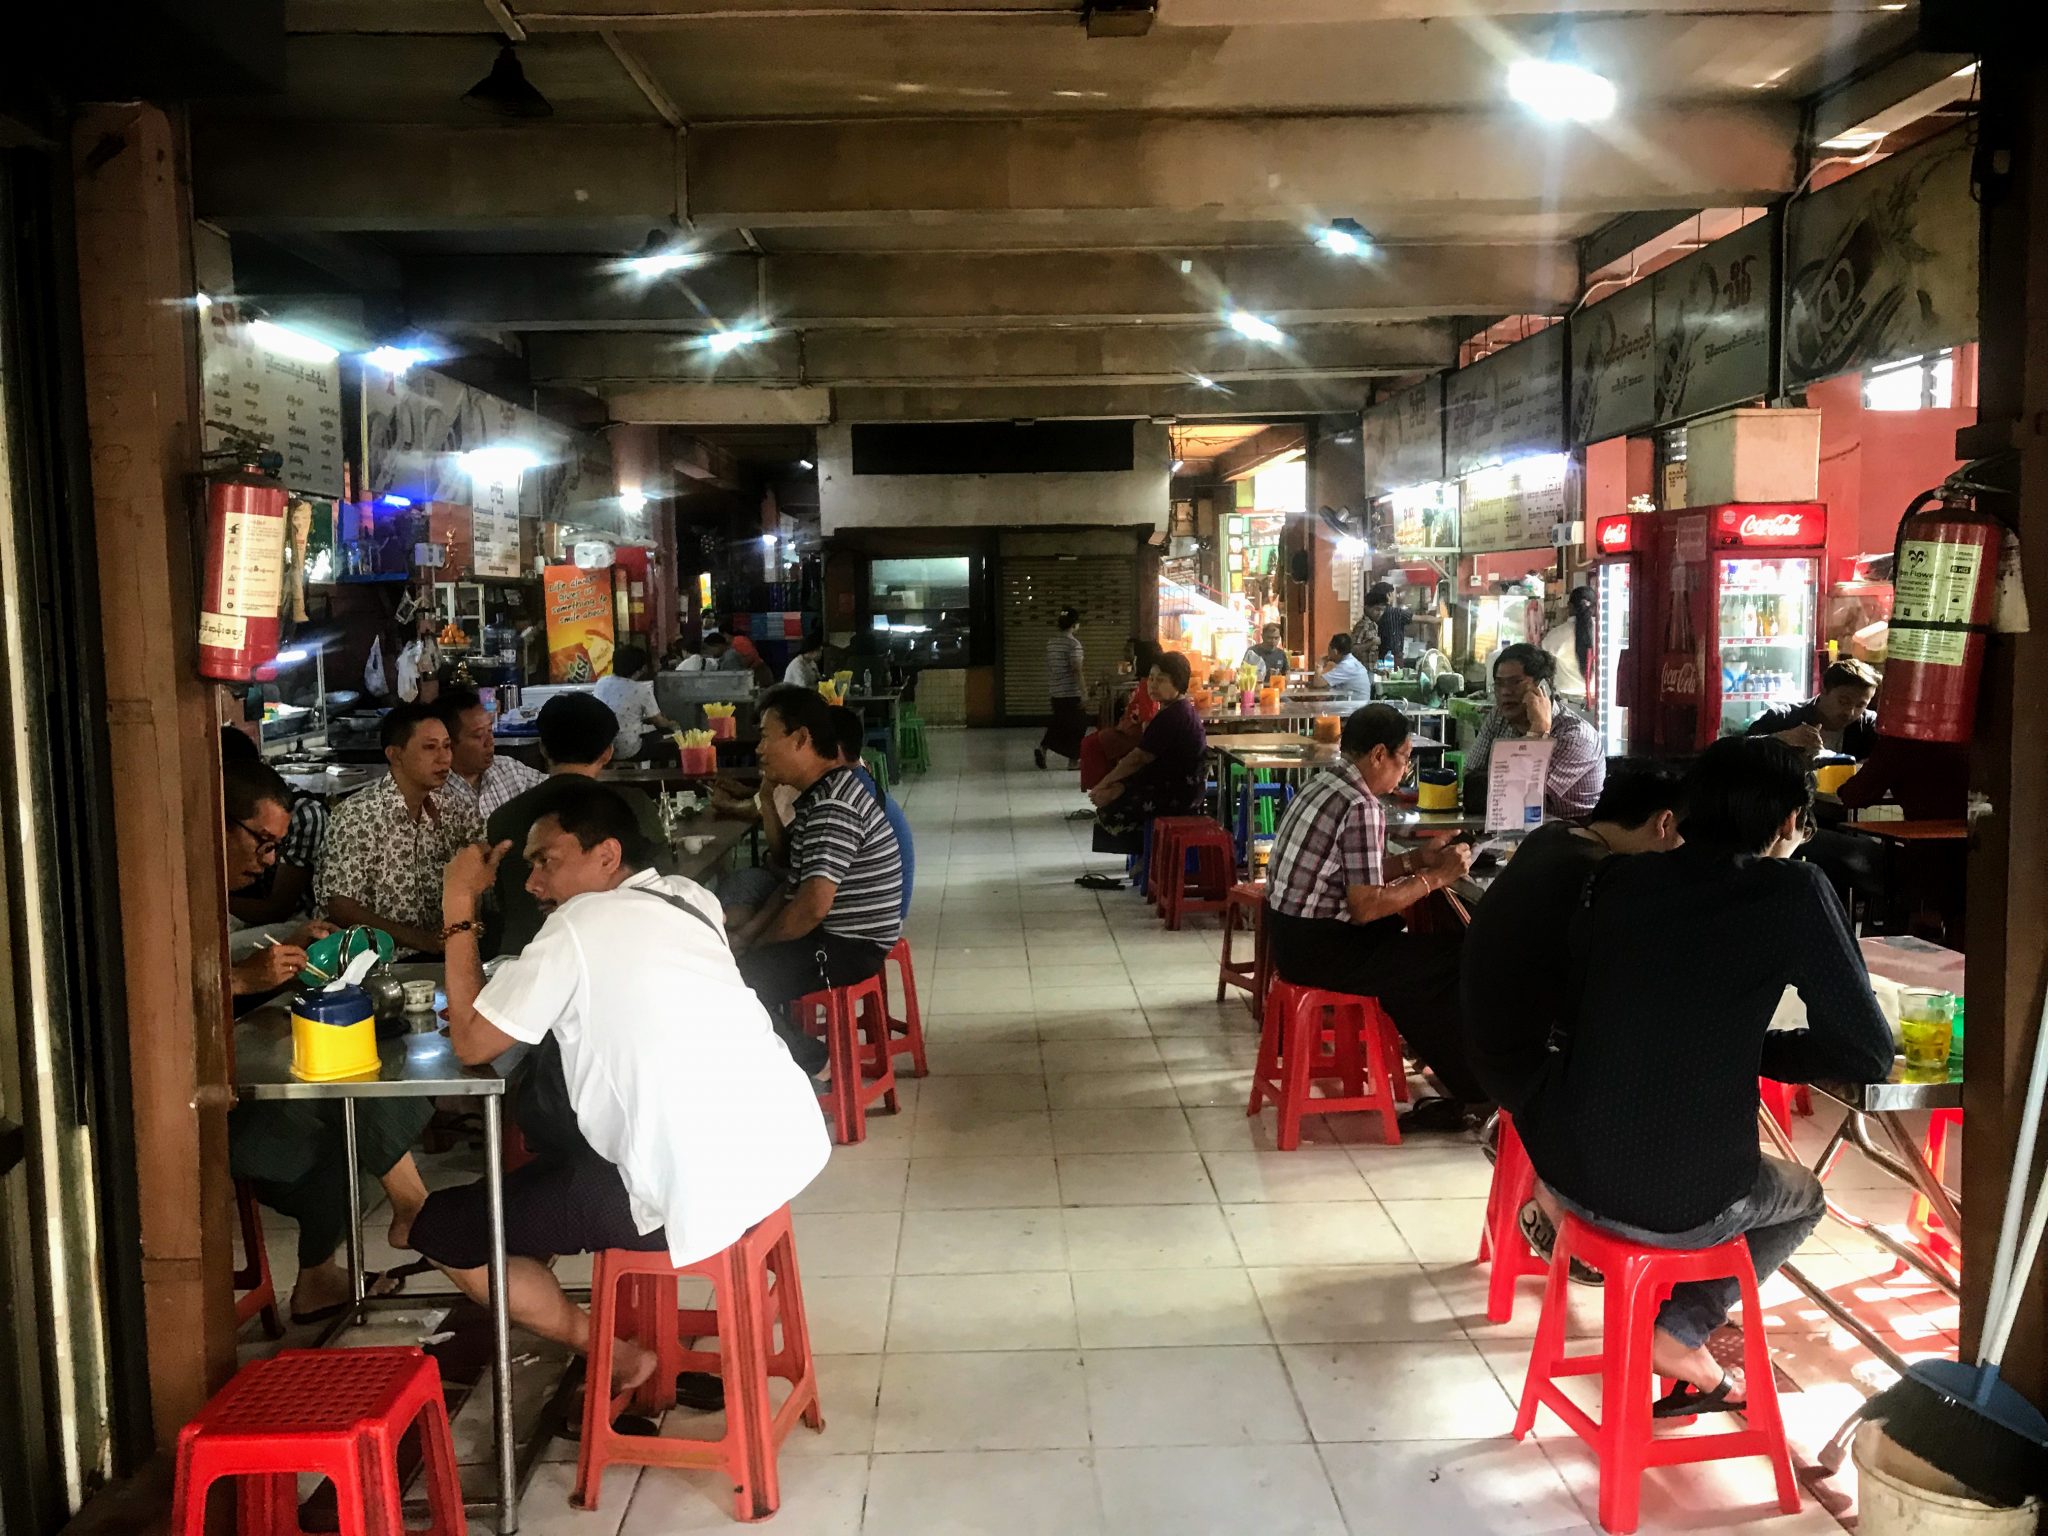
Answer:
[1647,502,1827,754]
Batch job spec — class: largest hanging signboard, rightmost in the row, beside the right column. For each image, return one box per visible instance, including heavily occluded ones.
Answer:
[1784,127,1978,389]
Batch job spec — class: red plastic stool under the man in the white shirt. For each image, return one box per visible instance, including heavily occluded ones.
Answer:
[575,1206,825,1520]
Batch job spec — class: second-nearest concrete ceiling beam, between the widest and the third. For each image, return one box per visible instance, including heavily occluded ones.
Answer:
[406,244,1577,330]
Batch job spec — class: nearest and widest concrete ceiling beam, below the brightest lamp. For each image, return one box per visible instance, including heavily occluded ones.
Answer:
[193,102,1798,230]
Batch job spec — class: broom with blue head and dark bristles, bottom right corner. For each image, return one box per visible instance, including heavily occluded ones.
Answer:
[1864,1004,2048,1507]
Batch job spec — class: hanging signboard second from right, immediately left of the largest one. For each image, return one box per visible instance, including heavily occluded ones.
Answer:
[1649,215,1778,426]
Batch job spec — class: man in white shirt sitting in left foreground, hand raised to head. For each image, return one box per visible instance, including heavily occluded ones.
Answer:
[412,782,831,1391]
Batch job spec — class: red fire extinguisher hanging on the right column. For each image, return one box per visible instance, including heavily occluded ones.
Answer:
[1878,489,2003,741]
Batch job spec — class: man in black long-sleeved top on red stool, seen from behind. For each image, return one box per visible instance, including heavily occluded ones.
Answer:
[1518,737,1892,1417]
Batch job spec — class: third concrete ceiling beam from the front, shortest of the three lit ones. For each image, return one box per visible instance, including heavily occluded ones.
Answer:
[528,322,1456,391]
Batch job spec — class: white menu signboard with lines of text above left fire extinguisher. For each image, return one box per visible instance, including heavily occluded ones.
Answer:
[199,309,342,500]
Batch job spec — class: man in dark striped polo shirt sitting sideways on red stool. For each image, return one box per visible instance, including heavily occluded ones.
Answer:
[733,688,903,1073]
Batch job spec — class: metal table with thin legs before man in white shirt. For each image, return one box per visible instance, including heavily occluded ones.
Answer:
[236,965,520,1536]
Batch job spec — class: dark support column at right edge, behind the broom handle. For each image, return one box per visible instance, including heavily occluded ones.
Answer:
[1958,48,2048,1403]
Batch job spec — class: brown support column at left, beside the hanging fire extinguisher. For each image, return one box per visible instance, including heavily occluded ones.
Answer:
[72,104,236,1444]
